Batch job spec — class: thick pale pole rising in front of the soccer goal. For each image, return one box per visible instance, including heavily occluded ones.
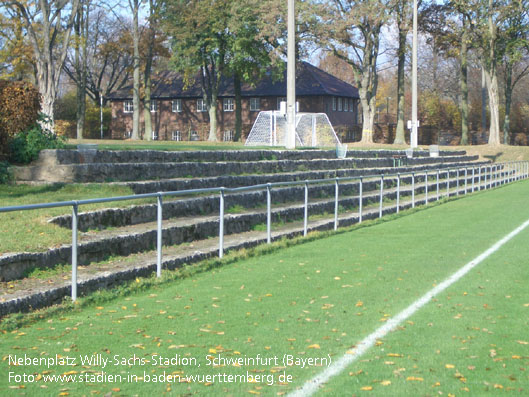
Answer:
[286,0,296,149]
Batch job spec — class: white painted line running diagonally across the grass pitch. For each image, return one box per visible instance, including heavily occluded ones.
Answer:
[290,219,529,397]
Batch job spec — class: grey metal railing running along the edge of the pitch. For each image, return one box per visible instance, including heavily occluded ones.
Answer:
[0,161,529,301]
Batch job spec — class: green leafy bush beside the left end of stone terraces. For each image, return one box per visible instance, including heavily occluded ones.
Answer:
[9,114,64,164]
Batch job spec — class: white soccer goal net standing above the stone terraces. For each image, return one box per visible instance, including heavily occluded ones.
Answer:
[245,111,341,147]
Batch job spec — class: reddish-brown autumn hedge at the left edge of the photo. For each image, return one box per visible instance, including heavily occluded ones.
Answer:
[0,80,40,156]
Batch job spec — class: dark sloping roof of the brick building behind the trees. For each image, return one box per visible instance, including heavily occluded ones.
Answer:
[109,62,359,100]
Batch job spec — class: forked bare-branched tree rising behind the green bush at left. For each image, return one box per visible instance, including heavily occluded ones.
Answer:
[4,0,79,130]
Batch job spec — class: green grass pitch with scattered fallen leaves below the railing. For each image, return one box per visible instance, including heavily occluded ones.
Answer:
[0,181,529,396]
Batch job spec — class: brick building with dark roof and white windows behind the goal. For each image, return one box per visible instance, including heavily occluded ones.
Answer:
[109,62,359,141]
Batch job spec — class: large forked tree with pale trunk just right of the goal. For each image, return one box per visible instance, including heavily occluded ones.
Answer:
[322,0,389,143]
